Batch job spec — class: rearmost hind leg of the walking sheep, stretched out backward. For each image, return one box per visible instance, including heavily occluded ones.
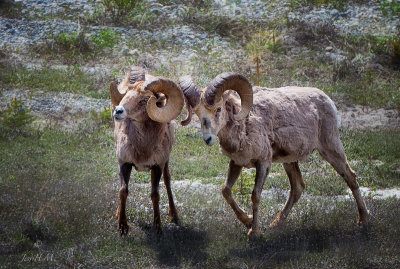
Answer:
[320,144,369,225]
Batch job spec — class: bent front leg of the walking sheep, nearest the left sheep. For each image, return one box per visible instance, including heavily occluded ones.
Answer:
[222,160,253,228]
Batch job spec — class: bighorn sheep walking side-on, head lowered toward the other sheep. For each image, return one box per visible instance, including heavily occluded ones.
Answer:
[180,73,368,236]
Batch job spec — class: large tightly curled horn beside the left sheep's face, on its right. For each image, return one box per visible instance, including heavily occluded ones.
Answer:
[143,77,184,123]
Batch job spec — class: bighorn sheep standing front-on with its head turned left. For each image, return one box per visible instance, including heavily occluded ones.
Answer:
[110,67,184,235]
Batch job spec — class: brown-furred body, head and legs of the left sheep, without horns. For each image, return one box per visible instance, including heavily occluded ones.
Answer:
[114,76,178,235]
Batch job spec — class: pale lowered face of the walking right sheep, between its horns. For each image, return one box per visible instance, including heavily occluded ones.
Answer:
[193,92,228,146]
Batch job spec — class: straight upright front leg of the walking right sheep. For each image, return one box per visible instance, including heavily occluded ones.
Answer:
[248,161,271,237]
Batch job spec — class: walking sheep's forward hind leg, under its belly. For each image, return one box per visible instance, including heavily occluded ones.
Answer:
[269,162,305,228]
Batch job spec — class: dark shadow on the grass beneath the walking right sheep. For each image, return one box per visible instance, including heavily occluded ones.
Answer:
[229,224,373,266]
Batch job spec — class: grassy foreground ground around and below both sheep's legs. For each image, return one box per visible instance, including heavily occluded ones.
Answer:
[0,121,400,268]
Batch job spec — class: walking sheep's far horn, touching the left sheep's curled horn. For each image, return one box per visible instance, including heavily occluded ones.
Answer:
[179,76,200,126]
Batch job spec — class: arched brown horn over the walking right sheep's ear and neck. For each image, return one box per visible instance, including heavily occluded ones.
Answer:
[204,73,253,120]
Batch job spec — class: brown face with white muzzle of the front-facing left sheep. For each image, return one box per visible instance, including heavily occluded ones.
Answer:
[113,88,151,122]
